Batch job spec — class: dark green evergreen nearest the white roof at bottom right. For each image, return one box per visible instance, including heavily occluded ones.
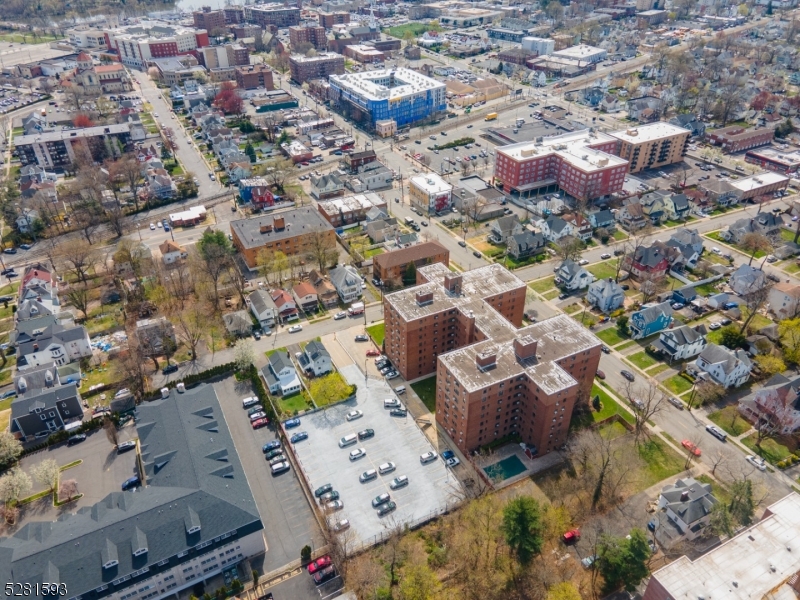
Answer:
[597,528,651,593]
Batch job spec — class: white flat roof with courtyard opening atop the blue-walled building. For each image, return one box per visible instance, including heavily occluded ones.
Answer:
[329,68,445,100]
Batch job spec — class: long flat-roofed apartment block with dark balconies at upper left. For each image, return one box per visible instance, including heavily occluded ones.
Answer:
[14,123,131,171]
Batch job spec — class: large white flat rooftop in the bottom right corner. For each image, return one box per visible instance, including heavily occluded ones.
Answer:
[651,492,800,600]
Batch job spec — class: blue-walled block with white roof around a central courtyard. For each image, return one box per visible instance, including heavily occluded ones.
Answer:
[328,68,447,128]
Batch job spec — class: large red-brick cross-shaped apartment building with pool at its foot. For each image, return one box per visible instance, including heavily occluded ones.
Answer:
[384,264,601,455]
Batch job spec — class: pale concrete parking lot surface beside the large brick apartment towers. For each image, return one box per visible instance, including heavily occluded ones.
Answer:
[294,365,464,547]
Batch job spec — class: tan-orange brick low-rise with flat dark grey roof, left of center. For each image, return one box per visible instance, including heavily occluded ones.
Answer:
[231,207,336,269]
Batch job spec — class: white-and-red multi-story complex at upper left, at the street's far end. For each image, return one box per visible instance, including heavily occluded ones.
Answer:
[105,21,209,70]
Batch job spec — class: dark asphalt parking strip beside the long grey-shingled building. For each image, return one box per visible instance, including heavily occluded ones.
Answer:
[214,377,322,573]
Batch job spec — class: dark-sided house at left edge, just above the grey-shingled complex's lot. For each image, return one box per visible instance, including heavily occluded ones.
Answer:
[9,382,83,441]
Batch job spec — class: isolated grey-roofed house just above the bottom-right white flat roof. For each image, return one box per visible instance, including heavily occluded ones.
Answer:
[658,477,718,540]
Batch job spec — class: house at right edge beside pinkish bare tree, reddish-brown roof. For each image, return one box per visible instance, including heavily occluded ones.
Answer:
[739,373,800,435]
